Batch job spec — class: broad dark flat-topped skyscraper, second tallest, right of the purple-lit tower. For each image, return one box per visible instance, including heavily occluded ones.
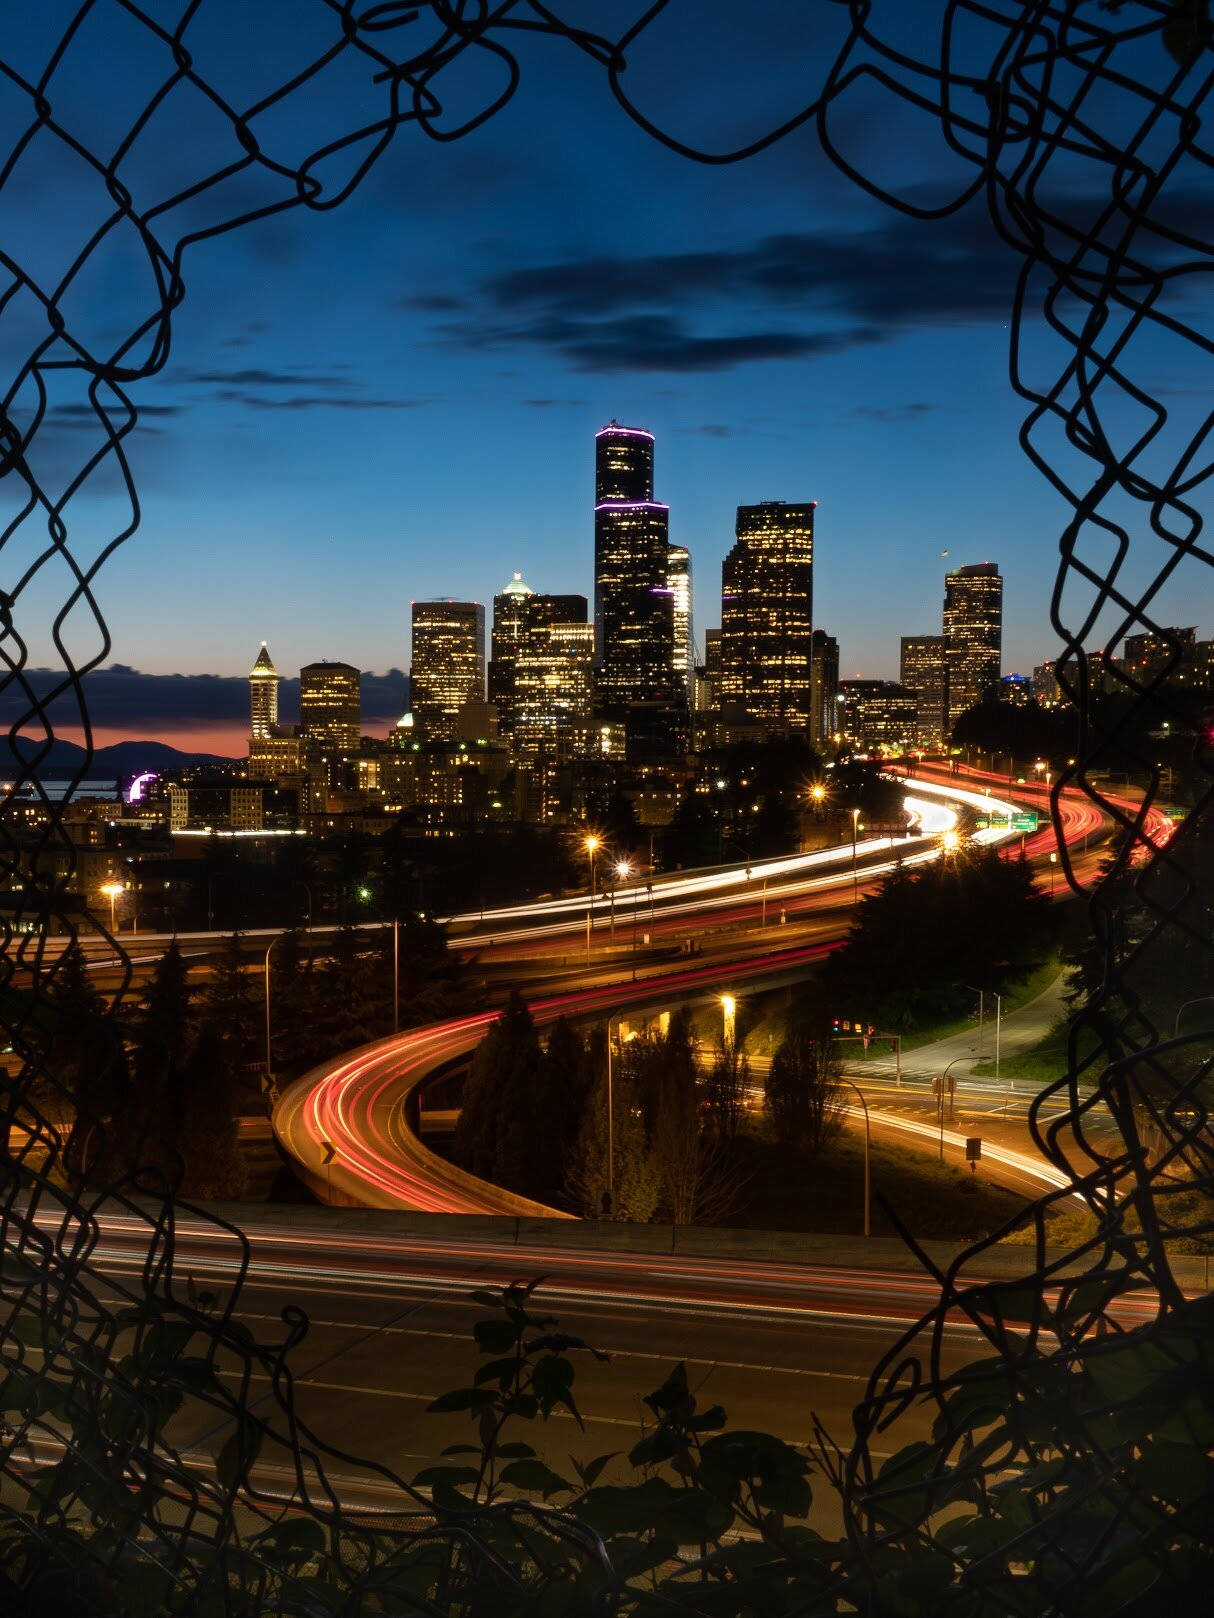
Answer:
[720,500,816,733]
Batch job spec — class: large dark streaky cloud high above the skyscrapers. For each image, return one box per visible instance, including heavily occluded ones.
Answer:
[420,209,1015,372]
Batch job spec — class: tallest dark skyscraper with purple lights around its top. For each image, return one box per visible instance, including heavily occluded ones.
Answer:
[594,421,686,714]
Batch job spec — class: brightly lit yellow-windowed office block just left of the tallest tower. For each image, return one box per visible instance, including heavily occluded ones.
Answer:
[513,613,594,762]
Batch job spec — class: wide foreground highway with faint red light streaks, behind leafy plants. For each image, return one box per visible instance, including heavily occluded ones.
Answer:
[71,1209,1171,1527]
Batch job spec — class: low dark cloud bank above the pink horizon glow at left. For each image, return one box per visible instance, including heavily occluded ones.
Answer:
[0,660,406,739]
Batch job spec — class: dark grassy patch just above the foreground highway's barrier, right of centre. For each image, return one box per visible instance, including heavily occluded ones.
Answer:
[727,1120,1028,1241]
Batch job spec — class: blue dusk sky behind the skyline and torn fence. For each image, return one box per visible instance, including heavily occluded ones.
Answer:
[0,0,1212,751]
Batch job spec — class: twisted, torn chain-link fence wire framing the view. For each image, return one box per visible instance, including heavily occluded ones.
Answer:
[0,0,1214,1612]
